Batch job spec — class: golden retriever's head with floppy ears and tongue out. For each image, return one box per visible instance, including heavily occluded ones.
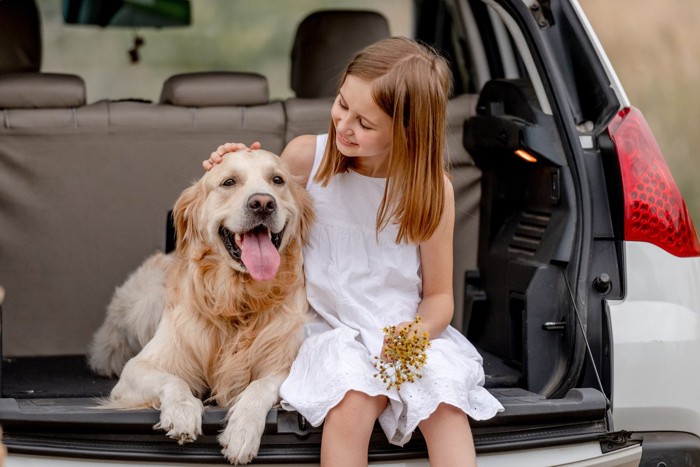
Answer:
[173,150,313,281]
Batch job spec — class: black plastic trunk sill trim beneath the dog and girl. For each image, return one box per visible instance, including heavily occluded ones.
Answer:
[0,388,607,463]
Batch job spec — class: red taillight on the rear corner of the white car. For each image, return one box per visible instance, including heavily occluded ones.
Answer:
[608,107,700,257]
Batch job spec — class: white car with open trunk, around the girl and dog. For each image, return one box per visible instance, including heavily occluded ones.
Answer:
[0,0,700,467]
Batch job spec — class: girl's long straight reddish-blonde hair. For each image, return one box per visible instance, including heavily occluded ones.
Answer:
[314,37,452,243]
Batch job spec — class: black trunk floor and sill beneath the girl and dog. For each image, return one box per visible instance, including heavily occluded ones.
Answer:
[0,354,609,463]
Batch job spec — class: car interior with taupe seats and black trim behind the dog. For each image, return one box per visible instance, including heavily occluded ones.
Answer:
[0,1,606,456]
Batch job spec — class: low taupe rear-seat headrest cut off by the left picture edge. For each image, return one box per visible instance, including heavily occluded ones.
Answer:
[0,73,85,109]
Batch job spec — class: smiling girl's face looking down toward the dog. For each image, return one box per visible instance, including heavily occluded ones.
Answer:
[331,75,392,176]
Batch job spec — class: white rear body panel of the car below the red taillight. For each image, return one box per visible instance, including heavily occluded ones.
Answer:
[608,242,700,435]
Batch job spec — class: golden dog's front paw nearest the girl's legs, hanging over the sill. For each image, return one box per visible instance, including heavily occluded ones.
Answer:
[219,410,265,465]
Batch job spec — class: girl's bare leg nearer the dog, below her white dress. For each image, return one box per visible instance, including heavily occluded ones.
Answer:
[321,391,388,467]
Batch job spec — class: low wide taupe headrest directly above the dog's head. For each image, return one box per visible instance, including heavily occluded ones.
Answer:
[160,71,270,107]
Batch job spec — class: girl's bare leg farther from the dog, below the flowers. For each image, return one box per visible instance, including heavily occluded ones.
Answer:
[418,404,476,467]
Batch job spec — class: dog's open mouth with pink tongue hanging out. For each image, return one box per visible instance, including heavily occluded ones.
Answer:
[219,224,284,281]
